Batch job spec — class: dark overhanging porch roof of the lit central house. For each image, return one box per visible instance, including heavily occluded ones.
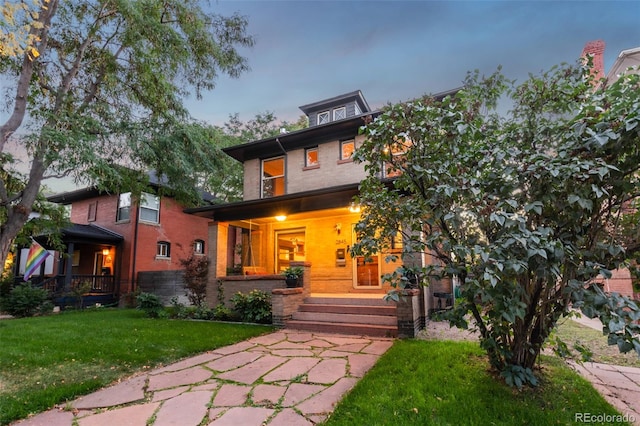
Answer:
[184,183,359,222]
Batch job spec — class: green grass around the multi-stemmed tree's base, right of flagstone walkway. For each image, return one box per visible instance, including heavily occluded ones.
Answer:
[325,340,618,426]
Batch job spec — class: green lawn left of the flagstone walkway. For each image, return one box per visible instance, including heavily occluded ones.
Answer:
[0,309,272,425]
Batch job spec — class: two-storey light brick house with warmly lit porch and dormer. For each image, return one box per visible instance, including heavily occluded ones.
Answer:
[187,91,451,335]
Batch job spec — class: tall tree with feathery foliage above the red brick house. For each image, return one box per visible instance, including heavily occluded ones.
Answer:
[0,0,254,265]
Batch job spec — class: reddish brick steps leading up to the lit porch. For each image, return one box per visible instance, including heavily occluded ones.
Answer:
[286,297,398,337]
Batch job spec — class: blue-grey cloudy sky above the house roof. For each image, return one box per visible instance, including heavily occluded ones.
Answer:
[188,0,640,125]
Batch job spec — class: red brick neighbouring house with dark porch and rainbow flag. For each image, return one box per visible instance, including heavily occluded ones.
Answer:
[48,180,210,303]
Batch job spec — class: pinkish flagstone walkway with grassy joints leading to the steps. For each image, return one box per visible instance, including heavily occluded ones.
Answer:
[17,330,393,426]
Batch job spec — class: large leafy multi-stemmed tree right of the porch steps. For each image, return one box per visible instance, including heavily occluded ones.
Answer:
[354,66,640,386]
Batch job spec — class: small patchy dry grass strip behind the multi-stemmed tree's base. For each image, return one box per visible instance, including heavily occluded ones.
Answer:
[556,319,640,367]
